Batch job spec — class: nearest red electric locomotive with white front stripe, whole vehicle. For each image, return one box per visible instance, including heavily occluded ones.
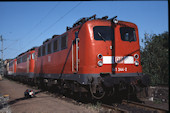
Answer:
[34,15,148,99]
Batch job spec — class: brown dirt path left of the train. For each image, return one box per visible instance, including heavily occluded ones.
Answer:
[0,79,97,113]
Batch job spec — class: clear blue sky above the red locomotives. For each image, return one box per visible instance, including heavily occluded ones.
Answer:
[0,1,169,59]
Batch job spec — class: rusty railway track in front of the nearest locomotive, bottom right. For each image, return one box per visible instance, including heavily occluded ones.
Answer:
[101,100,168,113]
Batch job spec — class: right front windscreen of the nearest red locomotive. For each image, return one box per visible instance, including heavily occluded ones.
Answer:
[120,27,136,42]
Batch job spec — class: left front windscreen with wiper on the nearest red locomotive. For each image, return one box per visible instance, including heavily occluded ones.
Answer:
[93,26,114,41]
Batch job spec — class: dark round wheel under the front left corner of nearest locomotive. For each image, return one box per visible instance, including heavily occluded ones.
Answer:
[90,84,105,99]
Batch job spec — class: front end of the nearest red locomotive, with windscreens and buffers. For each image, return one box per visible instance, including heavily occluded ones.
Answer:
[78,15,149,99]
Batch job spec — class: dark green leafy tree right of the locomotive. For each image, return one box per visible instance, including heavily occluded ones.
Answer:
[141,32,169,85]
